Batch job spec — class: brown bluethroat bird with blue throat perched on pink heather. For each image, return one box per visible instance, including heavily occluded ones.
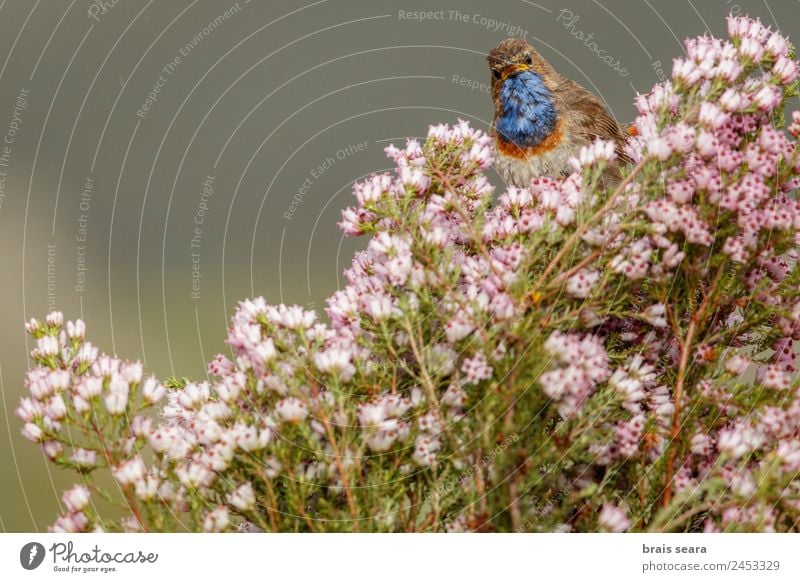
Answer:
[487,38,630,187]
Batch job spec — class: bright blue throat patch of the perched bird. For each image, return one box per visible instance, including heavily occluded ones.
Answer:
[495,71,558,148]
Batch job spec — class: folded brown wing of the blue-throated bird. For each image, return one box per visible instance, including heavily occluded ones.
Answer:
[556,77,631,164]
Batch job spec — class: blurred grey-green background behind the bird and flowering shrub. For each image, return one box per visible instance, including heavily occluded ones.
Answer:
[0,0,800,531]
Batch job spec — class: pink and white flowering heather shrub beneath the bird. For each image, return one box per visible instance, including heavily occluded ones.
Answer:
[18,17,800,531]
